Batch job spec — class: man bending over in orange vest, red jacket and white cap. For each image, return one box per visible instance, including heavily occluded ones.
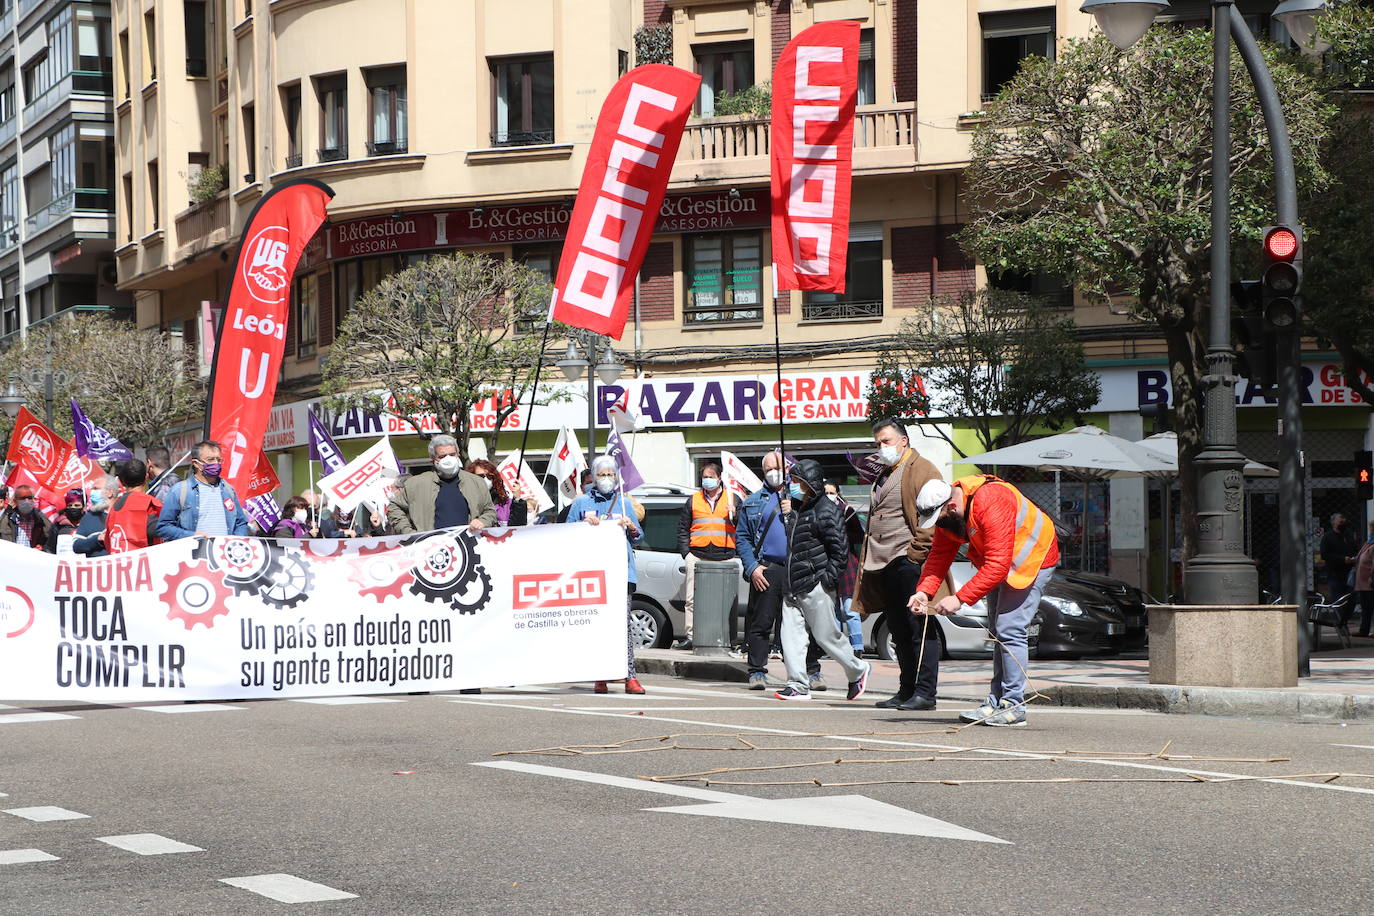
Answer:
[908,474,1059,726]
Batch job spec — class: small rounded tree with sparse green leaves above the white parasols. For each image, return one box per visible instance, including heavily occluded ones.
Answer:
[868,290,1102,456]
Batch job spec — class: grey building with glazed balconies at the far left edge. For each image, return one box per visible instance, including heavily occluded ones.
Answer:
[0,0,132,346]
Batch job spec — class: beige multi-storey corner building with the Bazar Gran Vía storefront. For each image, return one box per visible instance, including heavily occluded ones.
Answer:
[113,0,1370,596]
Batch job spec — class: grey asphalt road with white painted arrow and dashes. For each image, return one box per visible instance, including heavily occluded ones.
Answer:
[0,678,1374,915]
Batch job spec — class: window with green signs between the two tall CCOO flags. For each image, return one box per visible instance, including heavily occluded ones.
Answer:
[683,232,764,325]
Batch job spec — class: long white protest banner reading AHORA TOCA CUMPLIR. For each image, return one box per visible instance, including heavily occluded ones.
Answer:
[0,525,627,703]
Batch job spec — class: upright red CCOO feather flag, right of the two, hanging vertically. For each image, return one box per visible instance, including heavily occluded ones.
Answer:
[772,22,859,293]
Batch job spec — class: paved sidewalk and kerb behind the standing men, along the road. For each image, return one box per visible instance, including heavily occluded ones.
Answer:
[636,639,1374,720]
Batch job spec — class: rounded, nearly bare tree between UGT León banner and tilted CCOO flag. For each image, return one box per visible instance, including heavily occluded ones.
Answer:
[320,253,551,461]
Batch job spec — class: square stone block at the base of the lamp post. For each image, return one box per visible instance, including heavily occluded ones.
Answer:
[1146,604,1297,687]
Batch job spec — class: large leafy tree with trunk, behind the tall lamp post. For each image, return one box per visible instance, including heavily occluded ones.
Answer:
[963,27,1333,560]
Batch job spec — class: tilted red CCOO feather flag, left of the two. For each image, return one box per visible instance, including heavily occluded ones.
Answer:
[548,64,697,341]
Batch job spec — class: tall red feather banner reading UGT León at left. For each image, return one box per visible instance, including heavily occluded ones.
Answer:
[205,179,334,499]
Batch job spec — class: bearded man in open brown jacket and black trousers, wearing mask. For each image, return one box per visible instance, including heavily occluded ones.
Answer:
[853,419,943,710]
